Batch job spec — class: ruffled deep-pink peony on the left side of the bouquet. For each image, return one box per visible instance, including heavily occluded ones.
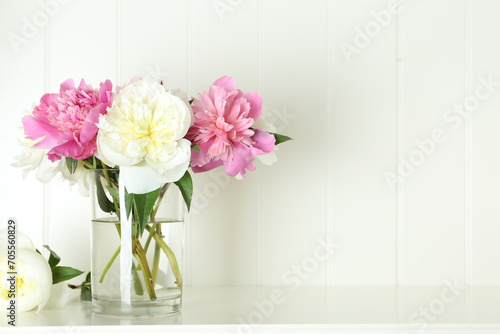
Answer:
[23,79,113,161]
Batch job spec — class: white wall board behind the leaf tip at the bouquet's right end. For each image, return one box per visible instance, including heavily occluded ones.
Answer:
[260,0,327,285]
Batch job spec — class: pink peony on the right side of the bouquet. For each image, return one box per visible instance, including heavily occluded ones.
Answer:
[186,76,275,177]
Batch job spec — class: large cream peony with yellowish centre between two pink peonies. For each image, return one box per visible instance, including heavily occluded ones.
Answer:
[96,78,191,194]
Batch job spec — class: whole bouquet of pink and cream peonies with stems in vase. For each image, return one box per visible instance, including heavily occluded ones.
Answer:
[14,76,290,306]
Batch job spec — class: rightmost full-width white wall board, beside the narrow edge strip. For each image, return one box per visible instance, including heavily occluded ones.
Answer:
[398,0,465,285]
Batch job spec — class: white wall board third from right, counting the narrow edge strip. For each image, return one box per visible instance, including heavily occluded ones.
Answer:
[327,0,396,285]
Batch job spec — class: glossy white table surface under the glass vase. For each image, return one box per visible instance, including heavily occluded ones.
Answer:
[0,286,500,334]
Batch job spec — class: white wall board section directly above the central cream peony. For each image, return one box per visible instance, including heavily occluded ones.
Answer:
[118,0,188,92]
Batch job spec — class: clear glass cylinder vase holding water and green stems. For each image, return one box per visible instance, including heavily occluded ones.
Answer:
[91,169,185,316]
